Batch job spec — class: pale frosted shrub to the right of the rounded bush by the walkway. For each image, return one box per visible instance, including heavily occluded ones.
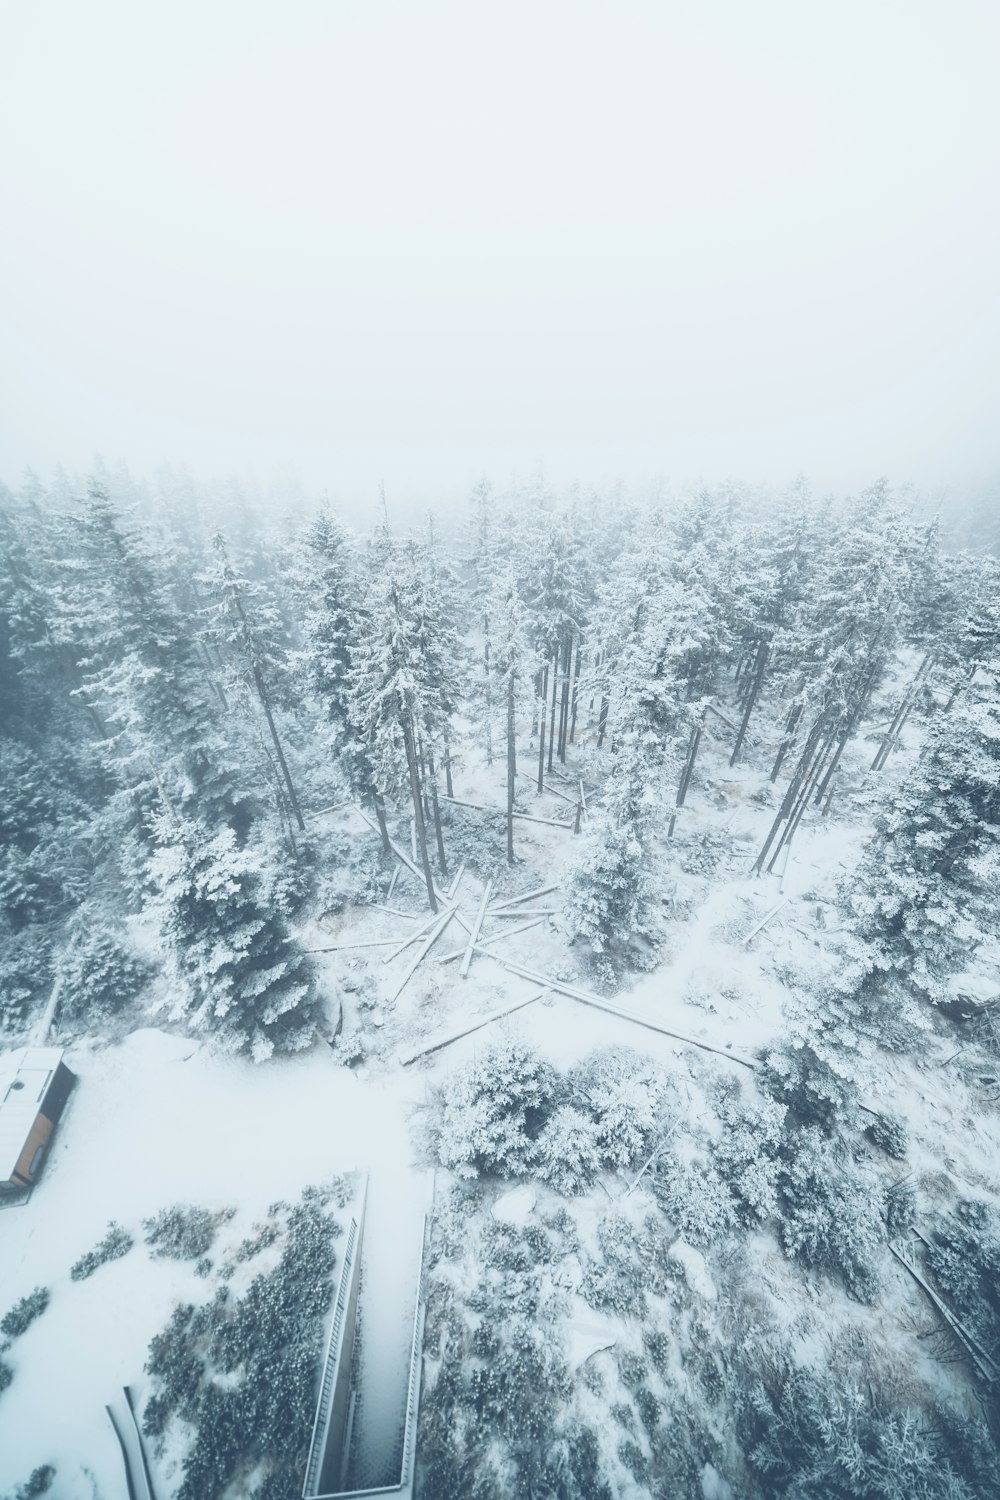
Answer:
[568,1047,666,1167]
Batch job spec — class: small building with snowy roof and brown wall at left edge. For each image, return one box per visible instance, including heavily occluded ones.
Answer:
[0,1047,76,1193]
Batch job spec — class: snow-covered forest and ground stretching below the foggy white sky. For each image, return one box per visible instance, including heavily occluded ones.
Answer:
[0,468,1000,1500]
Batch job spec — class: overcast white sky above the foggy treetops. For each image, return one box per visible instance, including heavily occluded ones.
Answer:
[0,0,1000,500]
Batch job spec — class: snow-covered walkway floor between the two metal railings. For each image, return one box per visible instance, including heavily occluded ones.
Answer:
[348,1176,430,1490]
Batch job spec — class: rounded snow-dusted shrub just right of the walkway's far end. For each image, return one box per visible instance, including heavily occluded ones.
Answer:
[436,1041,556,1178]
